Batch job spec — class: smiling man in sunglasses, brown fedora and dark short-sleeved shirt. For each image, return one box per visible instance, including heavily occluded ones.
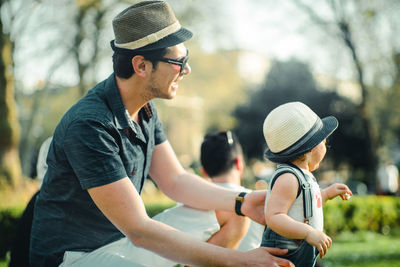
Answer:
[30,1,289,266]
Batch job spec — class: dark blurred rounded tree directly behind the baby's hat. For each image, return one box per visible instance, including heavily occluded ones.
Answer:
[234,60,367,184]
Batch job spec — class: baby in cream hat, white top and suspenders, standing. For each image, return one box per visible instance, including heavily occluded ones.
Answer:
[261,102,352,267]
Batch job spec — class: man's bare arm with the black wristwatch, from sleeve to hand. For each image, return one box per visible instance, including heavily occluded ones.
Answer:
[150,141,266,224]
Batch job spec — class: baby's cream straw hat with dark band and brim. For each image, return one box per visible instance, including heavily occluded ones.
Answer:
[263,102,338,163]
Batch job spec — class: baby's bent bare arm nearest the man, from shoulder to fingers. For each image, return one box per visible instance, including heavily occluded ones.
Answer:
[265,173,332,258]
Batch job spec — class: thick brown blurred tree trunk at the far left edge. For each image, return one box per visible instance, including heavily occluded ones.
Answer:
[0,16,22,188]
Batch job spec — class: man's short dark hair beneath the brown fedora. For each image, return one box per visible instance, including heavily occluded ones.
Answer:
[113,47,168,79]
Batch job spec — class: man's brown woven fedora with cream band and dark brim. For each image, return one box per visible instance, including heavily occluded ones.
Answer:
[111,1,193,53]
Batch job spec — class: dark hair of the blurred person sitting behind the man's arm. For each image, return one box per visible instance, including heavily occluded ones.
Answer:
[200,131,243,177]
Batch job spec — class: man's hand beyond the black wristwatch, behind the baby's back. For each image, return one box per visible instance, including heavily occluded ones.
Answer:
[241,190,267,225]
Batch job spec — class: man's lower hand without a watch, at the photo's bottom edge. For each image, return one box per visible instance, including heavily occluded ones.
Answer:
[242,247,294,267]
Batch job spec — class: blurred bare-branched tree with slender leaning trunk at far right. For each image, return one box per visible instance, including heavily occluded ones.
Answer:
[286,0,399,181]
